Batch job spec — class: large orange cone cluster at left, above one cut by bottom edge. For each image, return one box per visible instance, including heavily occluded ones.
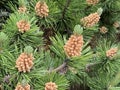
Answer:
[16,53,34,73]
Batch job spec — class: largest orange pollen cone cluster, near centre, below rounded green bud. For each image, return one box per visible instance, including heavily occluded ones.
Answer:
[64,35,84,57]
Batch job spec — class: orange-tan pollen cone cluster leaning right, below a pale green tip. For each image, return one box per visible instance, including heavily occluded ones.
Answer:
[81,13,100,27]
